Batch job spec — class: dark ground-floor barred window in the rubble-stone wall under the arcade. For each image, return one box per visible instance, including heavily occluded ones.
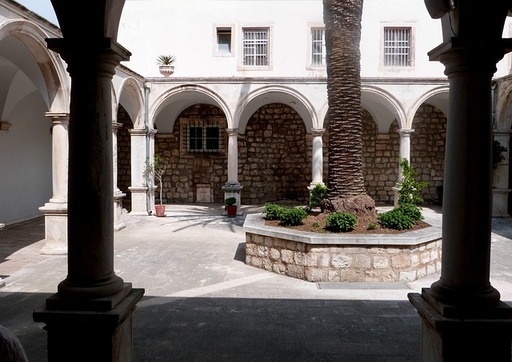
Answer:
[185,121,224,153]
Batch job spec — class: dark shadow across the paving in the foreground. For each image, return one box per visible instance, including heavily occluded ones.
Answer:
[0,293,421,362]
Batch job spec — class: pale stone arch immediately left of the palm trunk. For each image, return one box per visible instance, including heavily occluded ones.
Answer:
[236,86,318,134]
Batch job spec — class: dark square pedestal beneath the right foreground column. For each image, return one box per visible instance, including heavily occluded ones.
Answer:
[409,289,512,362]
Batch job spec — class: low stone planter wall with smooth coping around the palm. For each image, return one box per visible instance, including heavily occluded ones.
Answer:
[244,215,441,282]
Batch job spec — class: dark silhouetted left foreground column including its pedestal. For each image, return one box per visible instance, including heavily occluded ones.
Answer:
[33,29,144,362]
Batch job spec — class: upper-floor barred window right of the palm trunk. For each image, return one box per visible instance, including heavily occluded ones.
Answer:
[384,28,411,67]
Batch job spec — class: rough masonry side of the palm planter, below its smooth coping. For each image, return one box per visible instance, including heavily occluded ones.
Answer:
[246,232,441,282]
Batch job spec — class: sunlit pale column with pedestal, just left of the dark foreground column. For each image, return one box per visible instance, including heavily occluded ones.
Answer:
[39,112,69,254]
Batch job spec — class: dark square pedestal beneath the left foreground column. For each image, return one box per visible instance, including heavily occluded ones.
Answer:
[33,289,144,362]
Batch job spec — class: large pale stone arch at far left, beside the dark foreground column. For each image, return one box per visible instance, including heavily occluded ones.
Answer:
[0,19,70,113]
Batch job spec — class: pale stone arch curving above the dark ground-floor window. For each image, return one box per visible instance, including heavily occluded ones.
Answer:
[149,85,234,133]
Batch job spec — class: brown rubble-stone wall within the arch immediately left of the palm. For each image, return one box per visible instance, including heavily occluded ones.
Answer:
[238,103,312,205]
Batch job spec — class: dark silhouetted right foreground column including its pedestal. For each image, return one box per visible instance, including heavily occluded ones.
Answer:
[409,1,512,362]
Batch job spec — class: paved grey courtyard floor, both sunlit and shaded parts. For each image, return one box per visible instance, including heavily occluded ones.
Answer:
[0,205,512,362]
